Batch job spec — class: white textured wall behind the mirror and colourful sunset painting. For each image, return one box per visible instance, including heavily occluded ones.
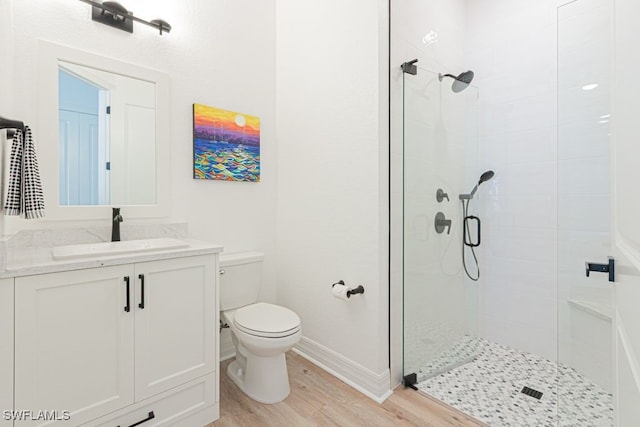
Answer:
[0,0,276,300]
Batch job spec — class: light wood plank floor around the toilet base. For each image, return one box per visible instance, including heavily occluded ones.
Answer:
[206,352,485,427]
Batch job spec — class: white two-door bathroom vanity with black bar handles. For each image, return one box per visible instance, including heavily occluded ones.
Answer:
[0,240,222,427]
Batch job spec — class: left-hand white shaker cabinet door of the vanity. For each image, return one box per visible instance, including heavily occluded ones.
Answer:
[15,265,134,426]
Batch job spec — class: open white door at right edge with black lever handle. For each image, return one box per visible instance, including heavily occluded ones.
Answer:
[612,0,640,427]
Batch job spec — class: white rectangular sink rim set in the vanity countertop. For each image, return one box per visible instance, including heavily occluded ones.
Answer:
[53,237,189,259]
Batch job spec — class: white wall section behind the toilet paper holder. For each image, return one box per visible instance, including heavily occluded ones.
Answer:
[277,0,389,398]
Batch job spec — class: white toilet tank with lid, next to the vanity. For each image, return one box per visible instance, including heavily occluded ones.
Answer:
[219,252,264,311]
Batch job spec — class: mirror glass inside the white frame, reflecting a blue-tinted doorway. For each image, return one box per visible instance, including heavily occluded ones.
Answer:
[58,61,156,206]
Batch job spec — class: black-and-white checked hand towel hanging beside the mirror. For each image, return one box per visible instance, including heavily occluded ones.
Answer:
[4,126,44,219]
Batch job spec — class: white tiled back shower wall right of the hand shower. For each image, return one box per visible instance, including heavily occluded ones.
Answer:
[465,0,611,368]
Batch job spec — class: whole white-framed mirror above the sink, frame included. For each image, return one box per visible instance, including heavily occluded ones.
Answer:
[37,41,170,219]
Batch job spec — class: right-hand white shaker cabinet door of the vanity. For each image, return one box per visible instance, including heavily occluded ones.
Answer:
[135,255,218,401]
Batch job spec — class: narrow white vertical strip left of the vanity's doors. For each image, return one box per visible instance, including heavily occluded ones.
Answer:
[0,279,13,427]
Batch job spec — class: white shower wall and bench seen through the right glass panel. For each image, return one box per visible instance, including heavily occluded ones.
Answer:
[558,0,616,392]
